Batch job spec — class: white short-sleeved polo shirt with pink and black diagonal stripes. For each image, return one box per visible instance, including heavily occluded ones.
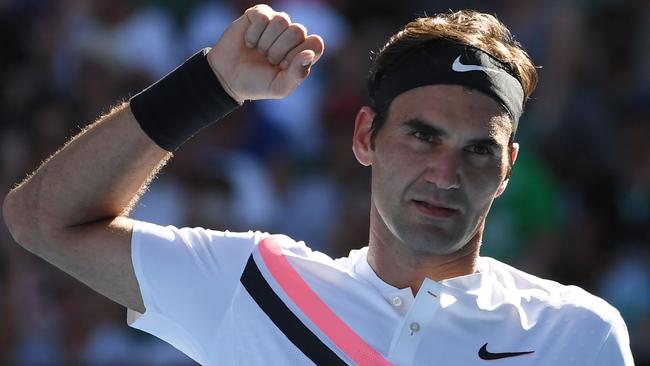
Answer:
[128,222,634,366]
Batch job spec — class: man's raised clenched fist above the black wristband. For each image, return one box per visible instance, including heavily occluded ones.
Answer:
[208,5,325,102]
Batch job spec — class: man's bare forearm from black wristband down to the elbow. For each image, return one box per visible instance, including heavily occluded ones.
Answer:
[4,104,171,249]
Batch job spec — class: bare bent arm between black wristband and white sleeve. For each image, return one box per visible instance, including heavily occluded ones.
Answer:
[3,104,171,311]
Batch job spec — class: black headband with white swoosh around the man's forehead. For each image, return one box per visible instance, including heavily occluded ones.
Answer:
[374,40,524,133]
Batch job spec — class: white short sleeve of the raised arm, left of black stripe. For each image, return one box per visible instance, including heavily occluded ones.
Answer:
[127,221,266,363]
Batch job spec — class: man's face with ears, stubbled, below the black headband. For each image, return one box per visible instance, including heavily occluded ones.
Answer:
[354,85,517,255]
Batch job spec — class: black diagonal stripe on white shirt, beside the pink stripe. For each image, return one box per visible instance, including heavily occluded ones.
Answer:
[240,255,347,365]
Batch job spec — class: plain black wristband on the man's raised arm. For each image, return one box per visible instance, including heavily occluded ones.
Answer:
[130,48,239,151]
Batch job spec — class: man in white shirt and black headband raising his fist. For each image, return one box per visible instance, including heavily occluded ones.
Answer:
[3,5,633,365]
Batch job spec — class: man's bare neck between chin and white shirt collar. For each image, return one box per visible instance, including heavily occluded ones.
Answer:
[368,219,483,295]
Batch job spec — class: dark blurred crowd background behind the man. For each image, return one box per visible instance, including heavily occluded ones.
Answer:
[0,0,650,365]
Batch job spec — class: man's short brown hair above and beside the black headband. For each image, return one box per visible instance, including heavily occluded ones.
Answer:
[368,10,537,148]
